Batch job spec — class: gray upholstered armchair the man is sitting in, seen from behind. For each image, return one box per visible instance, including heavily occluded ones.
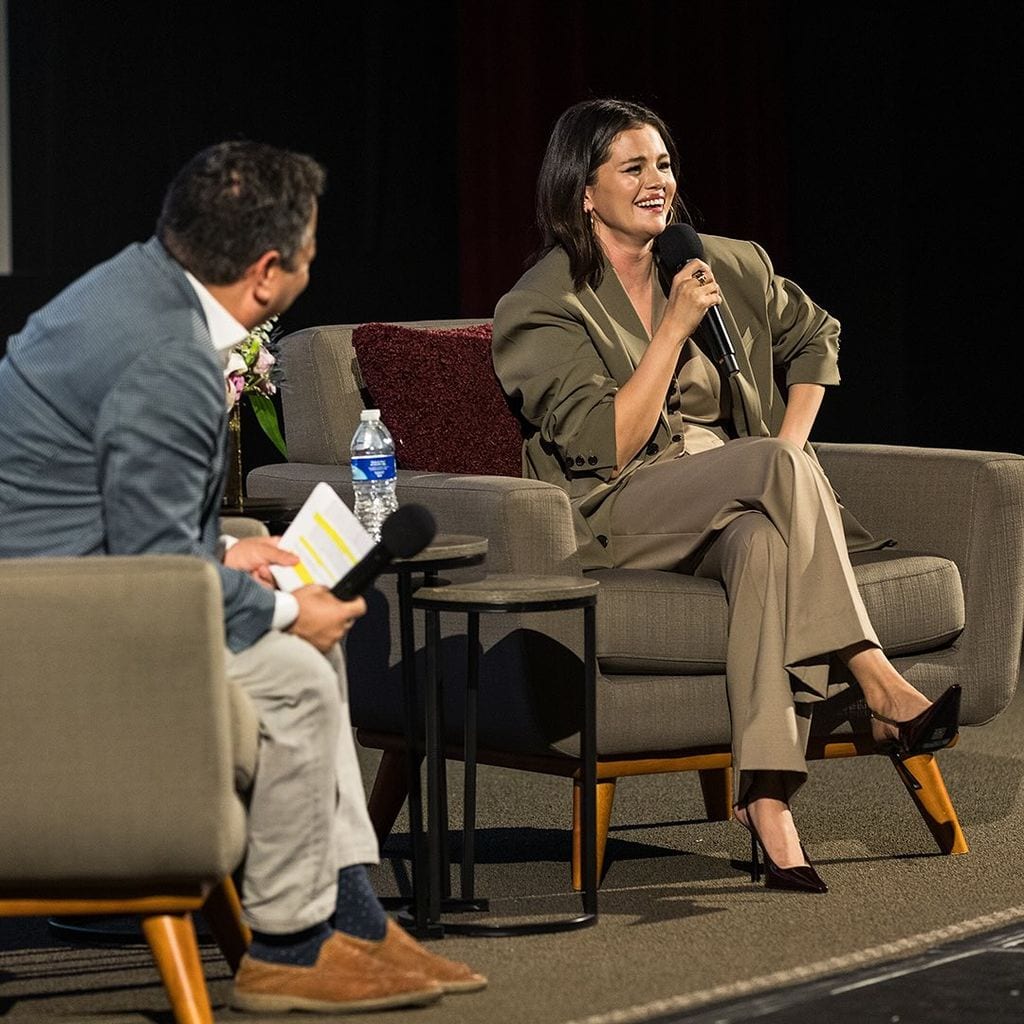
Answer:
[0,555,258,1024]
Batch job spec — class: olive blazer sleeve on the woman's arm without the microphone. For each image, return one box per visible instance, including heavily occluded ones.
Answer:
[752,243,840,387]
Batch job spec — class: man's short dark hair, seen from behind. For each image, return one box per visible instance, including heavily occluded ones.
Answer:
[157,141,327,285]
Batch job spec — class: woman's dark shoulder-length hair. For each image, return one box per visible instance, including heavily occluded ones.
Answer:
[537,99,690,291]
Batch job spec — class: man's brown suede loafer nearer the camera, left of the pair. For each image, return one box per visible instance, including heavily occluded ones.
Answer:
[228,932,443,1014]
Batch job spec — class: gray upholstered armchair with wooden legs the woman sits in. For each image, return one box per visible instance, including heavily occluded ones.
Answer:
[248,321,1024,888]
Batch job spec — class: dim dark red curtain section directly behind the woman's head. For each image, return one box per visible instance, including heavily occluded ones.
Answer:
[458,0,787,315]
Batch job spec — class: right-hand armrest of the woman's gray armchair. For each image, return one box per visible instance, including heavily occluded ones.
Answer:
[815,443,1024,724]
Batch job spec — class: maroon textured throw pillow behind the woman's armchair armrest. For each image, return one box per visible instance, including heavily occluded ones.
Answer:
[352,324,522,476]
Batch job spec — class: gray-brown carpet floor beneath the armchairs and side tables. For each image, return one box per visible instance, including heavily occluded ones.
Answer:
[0,679,1024,1024]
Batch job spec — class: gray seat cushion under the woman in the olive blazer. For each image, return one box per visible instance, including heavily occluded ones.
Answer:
[587,551,964,675]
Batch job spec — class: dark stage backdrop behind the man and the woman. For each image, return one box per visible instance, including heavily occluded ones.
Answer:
[0,0,1024,463]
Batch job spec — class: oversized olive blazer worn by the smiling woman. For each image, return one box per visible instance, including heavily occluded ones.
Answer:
[493,236,870,568]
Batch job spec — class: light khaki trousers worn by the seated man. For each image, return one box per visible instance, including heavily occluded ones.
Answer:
[227,631,379,934]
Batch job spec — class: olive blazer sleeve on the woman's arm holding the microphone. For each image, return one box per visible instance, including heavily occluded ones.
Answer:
[492,290,617,480]
